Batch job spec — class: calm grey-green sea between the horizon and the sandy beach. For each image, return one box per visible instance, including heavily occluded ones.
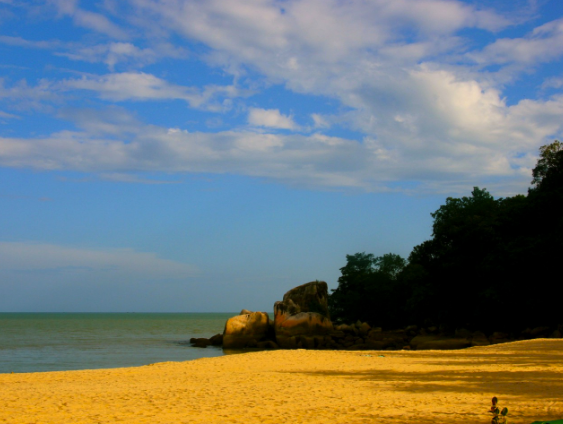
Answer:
[0,313,237,373]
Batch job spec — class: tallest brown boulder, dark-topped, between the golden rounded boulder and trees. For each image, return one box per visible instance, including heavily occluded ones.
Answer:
[274,281,333,349]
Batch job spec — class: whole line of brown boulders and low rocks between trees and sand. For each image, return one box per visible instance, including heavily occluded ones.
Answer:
[200,281,563,350]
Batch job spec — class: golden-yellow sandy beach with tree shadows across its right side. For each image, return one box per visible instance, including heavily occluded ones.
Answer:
[0,339,563,424]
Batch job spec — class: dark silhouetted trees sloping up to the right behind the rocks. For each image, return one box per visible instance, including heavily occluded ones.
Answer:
[329,140,563,331]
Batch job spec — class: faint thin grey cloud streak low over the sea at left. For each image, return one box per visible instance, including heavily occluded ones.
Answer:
[0,242,198,282]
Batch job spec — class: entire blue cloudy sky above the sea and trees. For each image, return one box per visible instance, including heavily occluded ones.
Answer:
[0,0,563,312]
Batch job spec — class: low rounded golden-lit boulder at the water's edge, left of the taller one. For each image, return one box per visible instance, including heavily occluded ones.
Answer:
[223,310,273,349]
